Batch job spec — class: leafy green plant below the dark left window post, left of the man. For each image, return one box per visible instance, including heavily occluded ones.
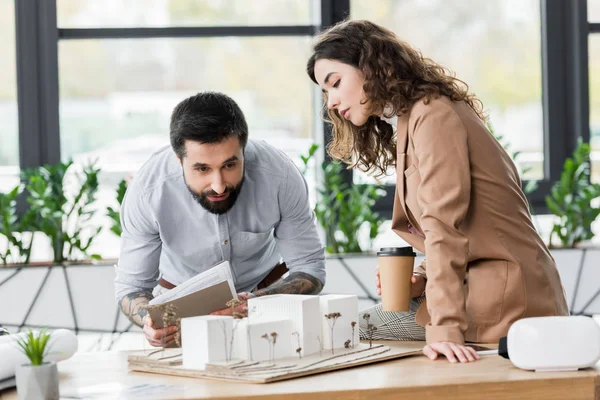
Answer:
[23,161,102,262]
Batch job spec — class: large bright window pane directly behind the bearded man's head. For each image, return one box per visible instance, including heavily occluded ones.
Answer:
[59,37,314,256]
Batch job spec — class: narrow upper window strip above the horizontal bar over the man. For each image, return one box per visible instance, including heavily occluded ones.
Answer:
[57,0,312,28]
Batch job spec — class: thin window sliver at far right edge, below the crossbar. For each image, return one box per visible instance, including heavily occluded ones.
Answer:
[588,34,600,183]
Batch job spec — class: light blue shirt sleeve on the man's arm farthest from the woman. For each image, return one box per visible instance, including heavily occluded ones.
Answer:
[115,180,162,302]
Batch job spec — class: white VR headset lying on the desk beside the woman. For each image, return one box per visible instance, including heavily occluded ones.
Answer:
[498,316,600,371]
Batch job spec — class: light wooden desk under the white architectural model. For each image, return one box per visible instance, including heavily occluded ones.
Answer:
[1,342,600,400]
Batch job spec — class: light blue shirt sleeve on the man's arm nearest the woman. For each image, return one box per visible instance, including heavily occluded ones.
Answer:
[275,161,325,286]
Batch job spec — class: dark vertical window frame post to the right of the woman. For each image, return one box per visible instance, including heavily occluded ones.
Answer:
[366,0,600,218]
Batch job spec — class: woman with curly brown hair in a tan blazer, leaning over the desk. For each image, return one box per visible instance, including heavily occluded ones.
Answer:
[307,21,568,362]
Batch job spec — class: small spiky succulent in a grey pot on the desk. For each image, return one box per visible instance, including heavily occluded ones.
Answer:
[15,330,59,400]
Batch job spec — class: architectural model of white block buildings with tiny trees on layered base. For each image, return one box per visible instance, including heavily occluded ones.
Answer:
[127,295,423,383]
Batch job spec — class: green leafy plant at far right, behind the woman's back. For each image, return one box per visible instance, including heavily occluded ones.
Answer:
[546,139,600,247]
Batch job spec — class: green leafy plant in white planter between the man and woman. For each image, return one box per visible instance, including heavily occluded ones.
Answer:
[301,144,385,303]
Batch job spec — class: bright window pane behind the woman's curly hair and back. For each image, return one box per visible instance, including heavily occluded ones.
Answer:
[350,0,544,182]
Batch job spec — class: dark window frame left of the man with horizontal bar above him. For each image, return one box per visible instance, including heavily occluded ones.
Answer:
[15,0,324,169]
